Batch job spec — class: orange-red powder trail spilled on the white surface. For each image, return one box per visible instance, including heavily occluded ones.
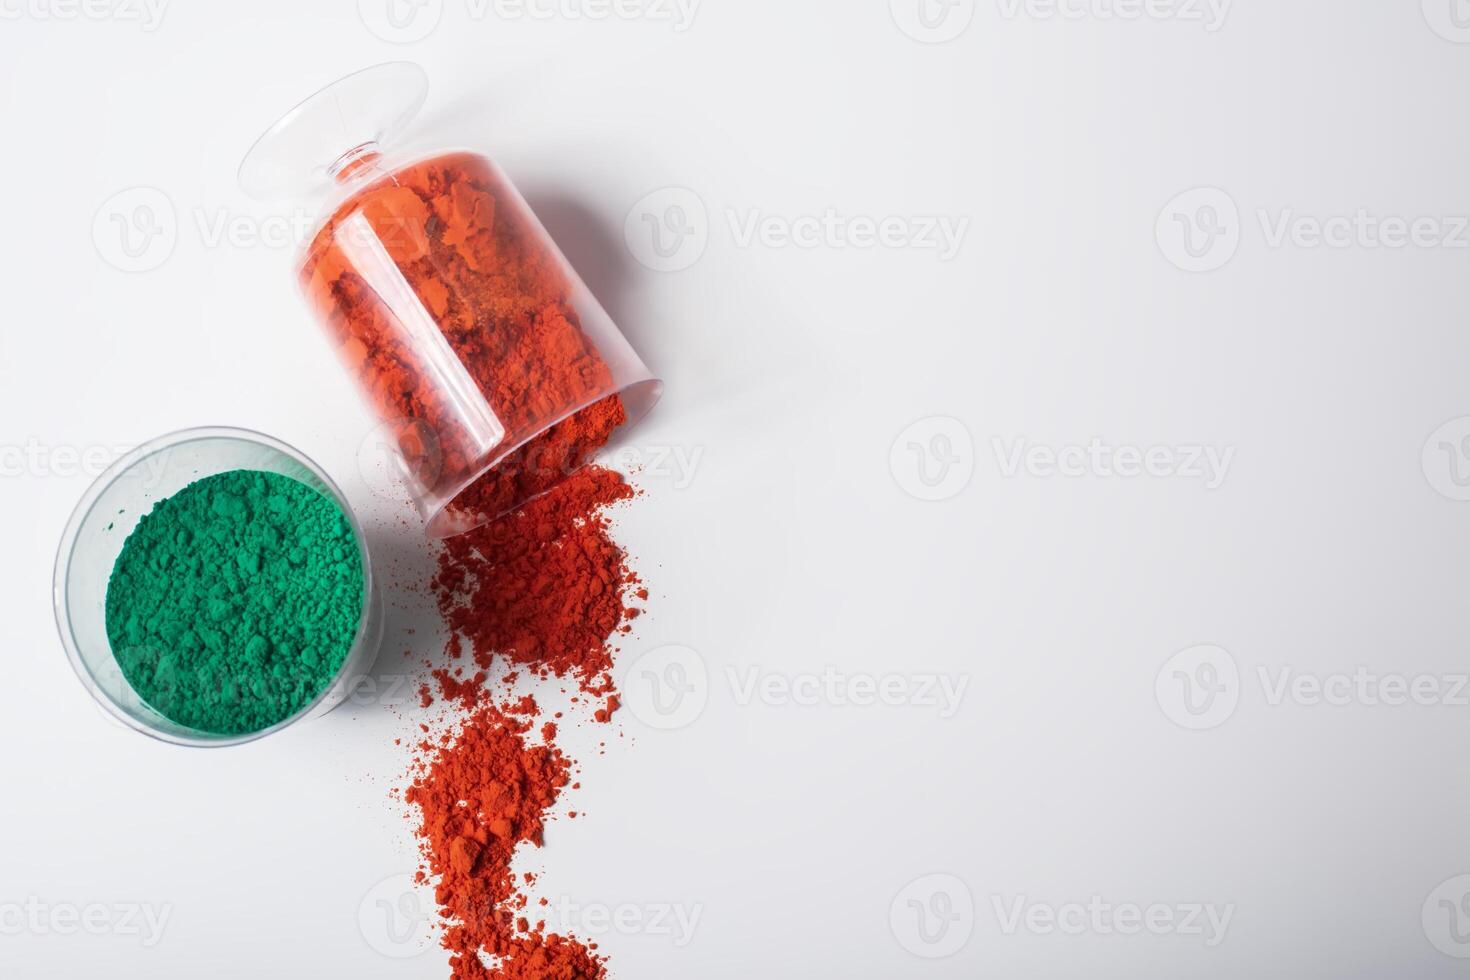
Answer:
[404,466,648,980]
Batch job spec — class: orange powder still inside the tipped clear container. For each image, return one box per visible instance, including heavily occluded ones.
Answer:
[301,153,628,535]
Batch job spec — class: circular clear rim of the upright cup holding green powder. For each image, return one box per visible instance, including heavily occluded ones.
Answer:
[51,426,375,748]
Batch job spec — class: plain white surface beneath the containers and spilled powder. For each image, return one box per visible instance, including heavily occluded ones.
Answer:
[0,0,1470,979]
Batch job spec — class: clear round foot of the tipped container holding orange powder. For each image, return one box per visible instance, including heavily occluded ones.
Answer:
[240,62,429,201]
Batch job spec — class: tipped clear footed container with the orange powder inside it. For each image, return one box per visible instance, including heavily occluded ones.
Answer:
[241,62,662,536]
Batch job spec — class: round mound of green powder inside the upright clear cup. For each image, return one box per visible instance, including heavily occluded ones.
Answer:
[107,470,363,735]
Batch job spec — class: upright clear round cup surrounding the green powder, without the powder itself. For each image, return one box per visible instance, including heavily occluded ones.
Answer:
[53,428,382,746]
